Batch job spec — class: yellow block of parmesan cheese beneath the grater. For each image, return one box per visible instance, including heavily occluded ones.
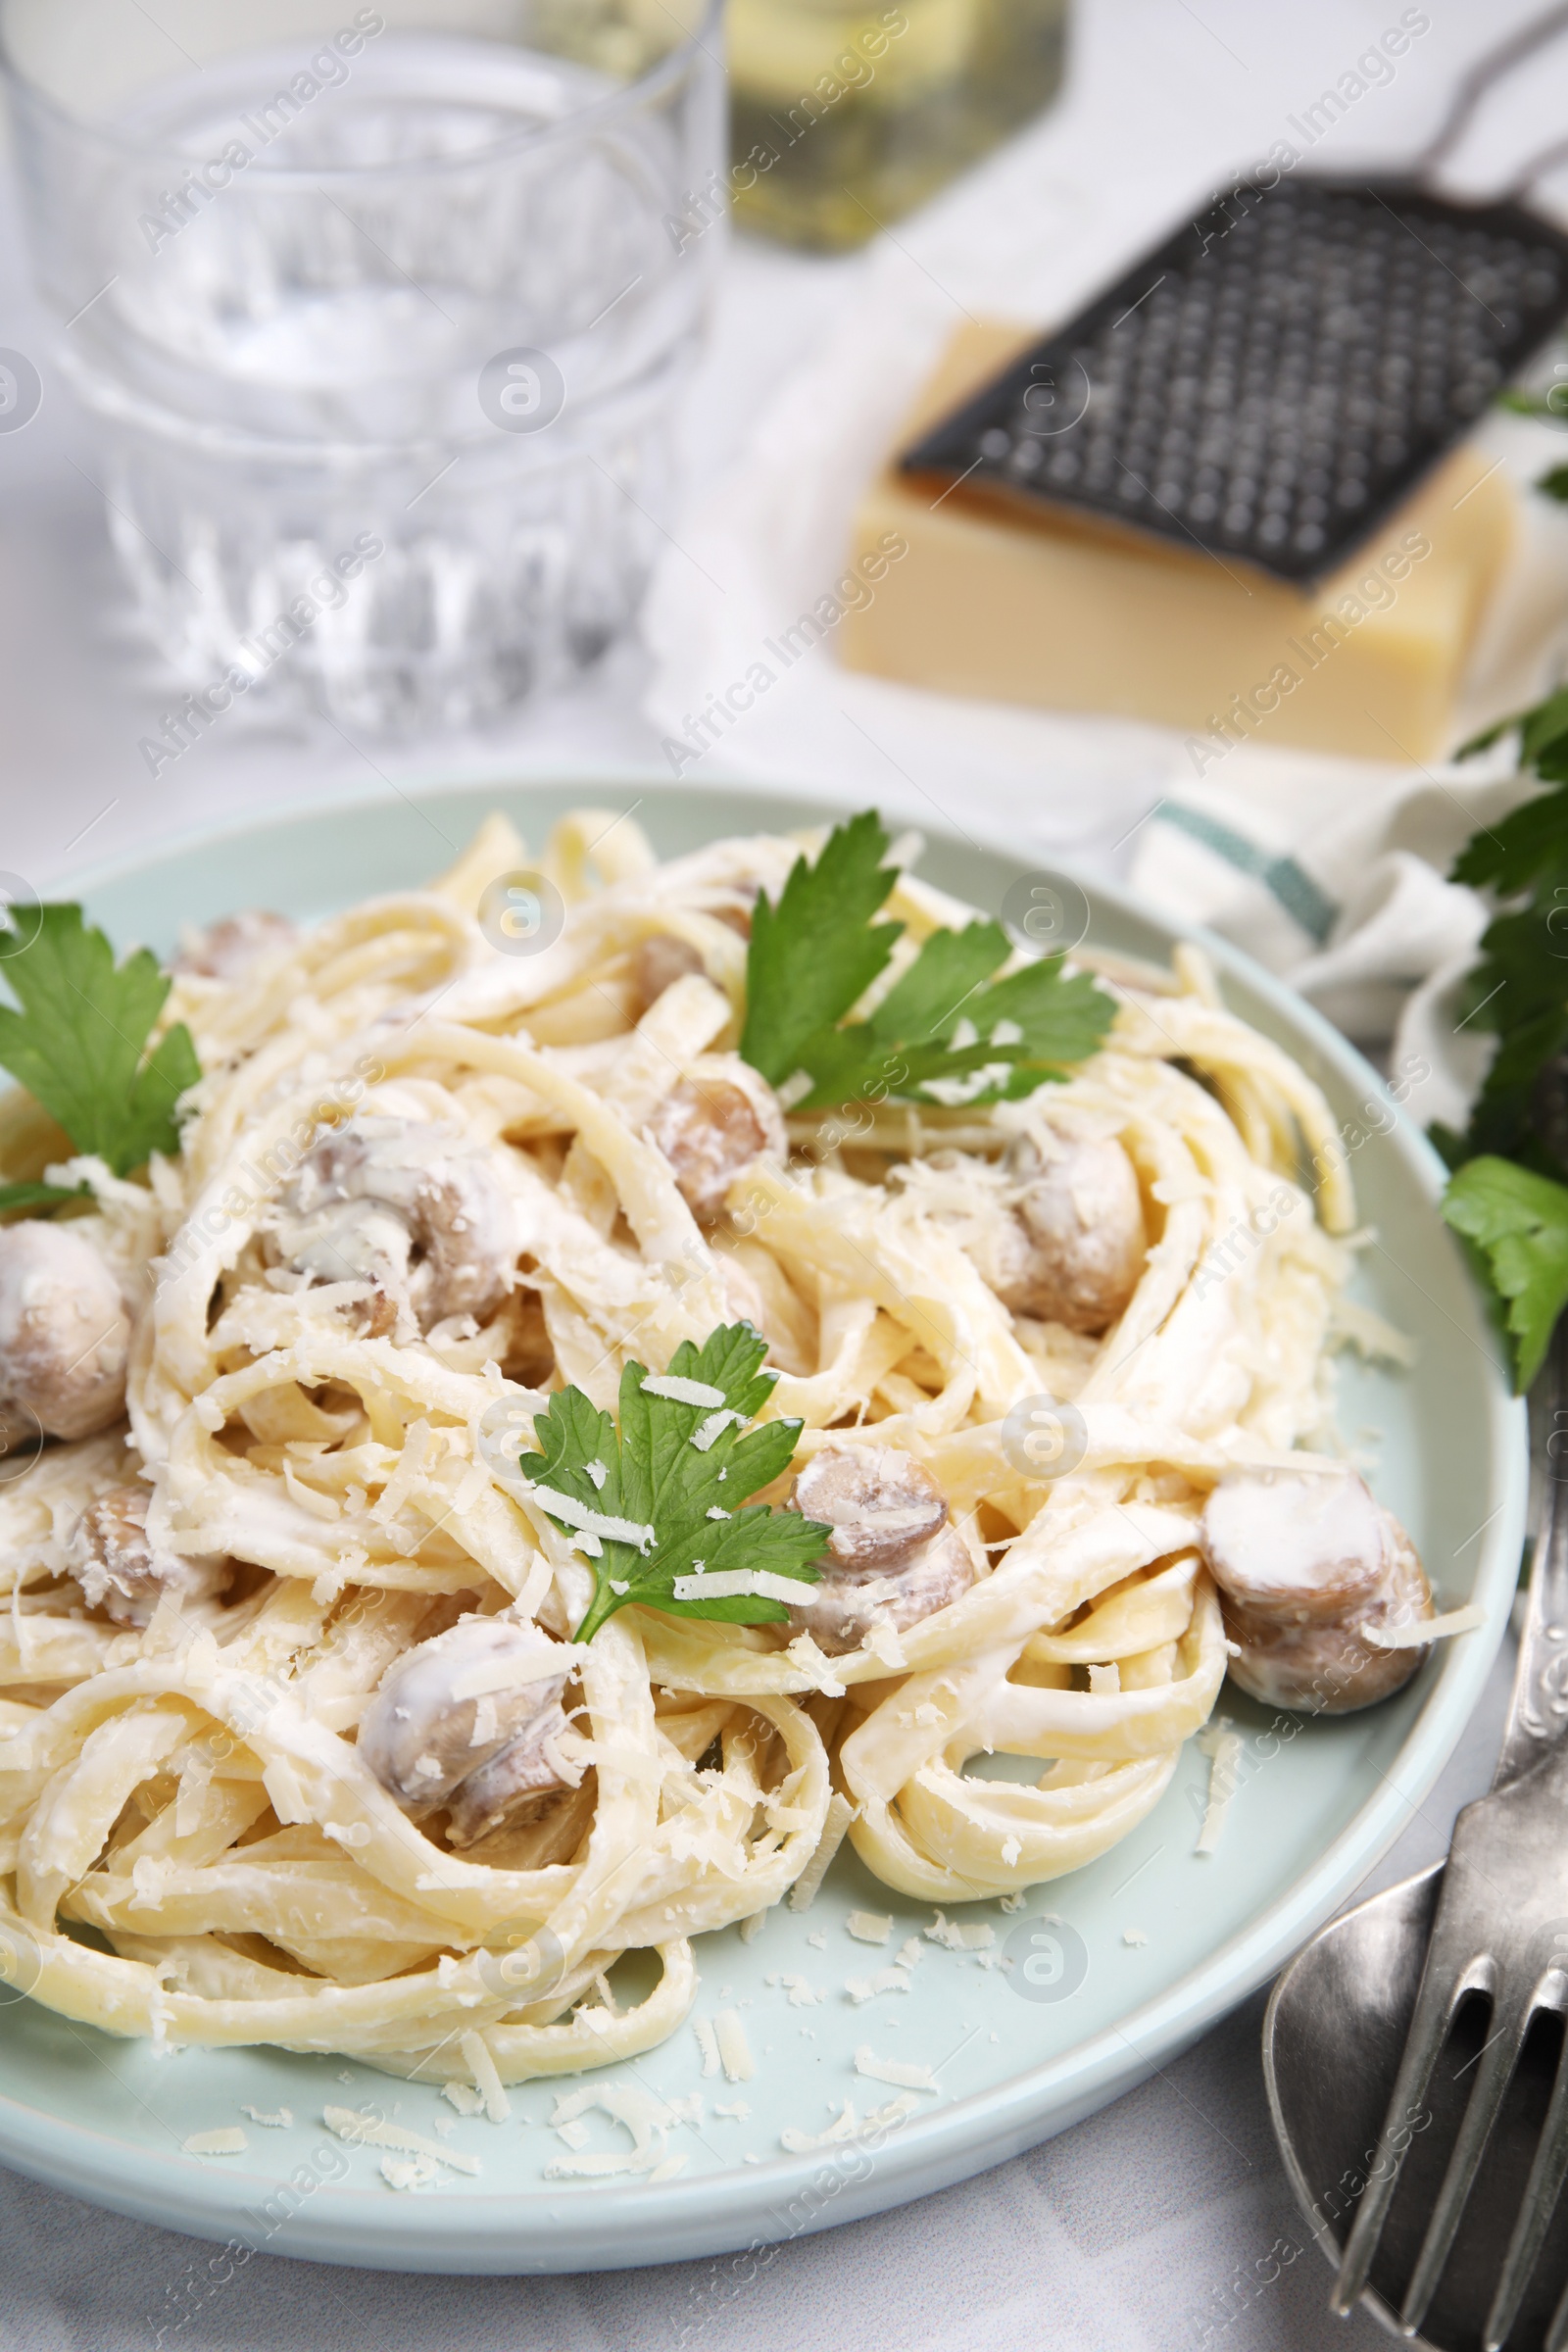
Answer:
[842,324,1516,771]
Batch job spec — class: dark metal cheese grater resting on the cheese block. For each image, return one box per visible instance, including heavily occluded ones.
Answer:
[898,7,1568,583]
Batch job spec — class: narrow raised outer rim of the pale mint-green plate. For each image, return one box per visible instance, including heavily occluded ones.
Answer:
[0,760,1528,2275]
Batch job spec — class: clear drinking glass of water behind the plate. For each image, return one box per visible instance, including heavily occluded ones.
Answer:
[0,0,724,729]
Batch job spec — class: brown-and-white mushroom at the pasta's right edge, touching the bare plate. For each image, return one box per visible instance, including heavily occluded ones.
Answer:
[1201,1470,1432,1715]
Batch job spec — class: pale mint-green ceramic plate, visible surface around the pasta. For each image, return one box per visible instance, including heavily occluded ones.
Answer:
[0,781,1526,2277]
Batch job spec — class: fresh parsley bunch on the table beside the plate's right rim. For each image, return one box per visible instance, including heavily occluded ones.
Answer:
[1432,689,1568,1390]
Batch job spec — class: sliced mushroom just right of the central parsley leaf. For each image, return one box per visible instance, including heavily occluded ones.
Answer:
[790,1446,976,1658]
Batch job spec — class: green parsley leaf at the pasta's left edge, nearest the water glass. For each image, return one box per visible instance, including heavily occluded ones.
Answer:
[0,906,202,1176]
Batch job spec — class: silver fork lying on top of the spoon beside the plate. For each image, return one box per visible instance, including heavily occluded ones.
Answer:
[1331,1315,1568,2352]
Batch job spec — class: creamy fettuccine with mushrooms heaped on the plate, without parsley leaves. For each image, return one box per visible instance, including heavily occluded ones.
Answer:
[0,811,1420,2082]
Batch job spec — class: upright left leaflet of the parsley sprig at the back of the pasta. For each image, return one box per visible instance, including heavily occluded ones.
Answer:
[741,809,903,1087]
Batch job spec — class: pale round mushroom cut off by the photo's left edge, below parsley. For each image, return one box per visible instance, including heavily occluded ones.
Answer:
[0,1218,131,1437]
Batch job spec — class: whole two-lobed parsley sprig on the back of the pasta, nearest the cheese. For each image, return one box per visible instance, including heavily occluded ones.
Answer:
[741,811,1114,1110]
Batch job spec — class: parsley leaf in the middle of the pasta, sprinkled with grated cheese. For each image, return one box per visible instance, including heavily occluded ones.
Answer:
[522,1324,832,1642]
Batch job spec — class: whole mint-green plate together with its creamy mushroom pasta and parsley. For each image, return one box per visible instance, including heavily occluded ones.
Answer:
[0,783,1526,2267]
